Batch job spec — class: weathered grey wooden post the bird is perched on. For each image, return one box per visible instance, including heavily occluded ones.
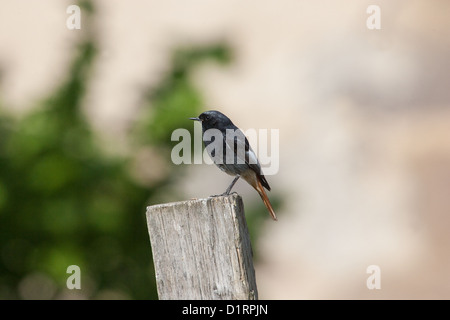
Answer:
[147,194,258,300]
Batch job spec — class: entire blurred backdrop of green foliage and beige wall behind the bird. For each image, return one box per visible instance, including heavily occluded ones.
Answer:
[0,0,450,299]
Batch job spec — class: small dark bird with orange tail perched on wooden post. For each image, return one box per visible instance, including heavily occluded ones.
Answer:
[190,110,277,220]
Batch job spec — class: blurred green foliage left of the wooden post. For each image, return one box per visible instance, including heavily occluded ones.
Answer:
[0,5,230,299]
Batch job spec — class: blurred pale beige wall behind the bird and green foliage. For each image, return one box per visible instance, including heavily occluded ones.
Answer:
[0,0,450,299]
